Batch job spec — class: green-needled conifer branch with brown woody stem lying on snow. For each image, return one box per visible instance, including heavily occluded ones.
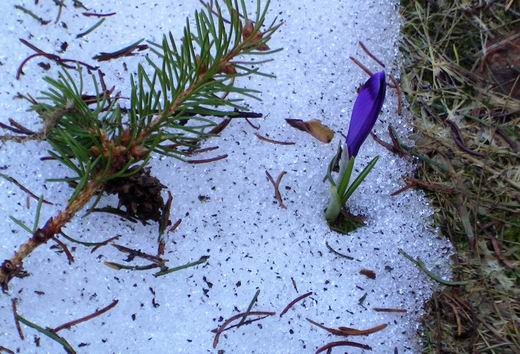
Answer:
[0,0,281,290]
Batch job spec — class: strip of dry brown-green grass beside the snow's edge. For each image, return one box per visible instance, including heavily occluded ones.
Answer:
[401,0,520,353]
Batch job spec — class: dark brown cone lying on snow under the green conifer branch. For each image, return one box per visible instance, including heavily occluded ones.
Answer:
[105,169,165,223]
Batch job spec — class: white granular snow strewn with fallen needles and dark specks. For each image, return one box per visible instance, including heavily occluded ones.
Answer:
[0,0,450,353]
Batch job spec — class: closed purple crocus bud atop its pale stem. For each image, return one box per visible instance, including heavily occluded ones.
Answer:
[346,71,386,158]
